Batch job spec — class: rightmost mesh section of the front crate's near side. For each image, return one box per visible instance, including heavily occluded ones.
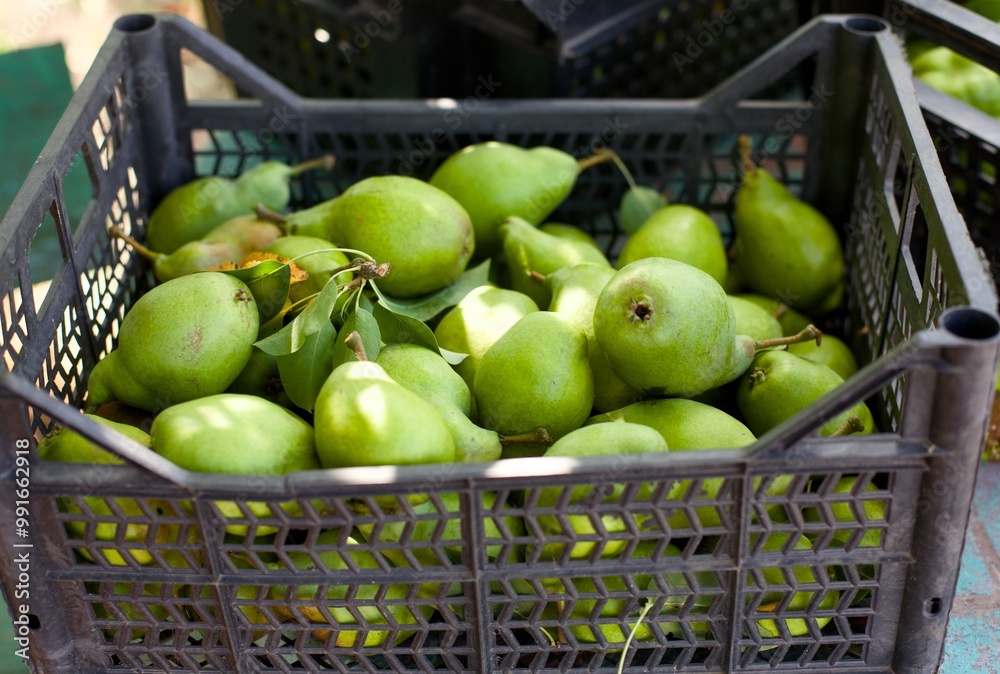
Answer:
[739,471,900,669]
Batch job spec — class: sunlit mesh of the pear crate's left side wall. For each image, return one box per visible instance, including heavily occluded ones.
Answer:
[0,71,140,438]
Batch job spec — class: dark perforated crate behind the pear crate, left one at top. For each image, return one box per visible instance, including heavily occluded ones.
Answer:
[203,0,464,98]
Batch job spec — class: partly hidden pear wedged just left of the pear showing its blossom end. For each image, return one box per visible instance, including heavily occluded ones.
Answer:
[545,262,642,412]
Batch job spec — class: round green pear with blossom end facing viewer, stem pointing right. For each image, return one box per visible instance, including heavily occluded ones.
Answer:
[594,257,820,398]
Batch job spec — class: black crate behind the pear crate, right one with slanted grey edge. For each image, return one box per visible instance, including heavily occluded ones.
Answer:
[455,0,812,98]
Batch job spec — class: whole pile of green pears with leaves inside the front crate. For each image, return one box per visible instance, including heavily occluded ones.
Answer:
[42,142,878,646]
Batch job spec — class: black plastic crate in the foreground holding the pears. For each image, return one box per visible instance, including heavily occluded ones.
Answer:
[0,11,1000,673]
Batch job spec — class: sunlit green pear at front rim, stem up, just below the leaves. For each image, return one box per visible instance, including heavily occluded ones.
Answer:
[313,360,455,468]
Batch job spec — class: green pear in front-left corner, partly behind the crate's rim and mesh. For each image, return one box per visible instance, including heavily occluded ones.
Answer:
[38,414,179,566]
